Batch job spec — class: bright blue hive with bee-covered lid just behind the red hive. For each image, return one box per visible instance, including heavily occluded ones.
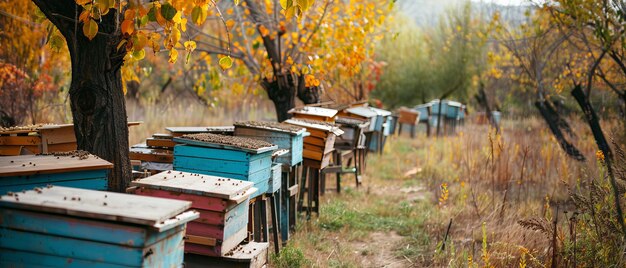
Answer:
[174,133,277,198]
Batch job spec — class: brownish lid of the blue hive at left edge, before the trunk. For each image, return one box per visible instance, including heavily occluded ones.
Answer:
[0,153,113,177]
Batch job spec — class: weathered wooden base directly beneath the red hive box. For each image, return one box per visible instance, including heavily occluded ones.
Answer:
[185,242,269,268]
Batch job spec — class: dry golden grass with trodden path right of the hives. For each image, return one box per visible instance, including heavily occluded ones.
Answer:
[272,118,610,267]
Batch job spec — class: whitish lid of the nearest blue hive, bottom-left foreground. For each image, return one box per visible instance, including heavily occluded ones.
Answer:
[0,186,197,230]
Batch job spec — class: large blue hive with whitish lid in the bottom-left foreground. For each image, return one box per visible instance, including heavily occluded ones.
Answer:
[0,186,199,267]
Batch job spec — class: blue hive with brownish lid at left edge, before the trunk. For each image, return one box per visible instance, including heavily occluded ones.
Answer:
[0,152,113,194]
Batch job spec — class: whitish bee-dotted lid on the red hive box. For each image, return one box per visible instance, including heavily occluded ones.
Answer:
[131,170,256,201]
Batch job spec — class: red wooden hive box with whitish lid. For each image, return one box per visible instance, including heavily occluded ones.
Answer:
[131,171,257,256]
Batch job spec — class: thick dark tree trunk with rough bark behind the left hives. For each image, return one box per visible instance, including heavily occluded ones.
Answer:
[33,0,131,192]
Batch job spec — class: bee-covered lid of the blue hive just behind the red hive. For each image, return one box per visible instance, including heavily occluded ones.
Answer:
[174,133,278,154]
